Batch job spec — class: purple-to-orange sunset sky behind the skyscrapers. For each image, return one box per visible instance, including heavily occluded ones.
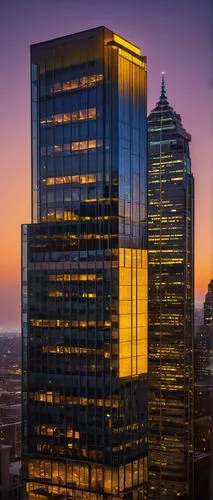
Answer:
[0,0,213,330]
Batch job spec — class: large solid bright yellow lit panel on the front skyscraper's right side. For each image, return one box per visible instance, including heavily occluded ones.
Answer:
[119,249,148,377]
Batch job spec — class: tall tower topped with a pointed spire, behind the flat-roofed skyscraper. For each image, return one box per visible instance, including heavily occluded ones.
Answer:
[148,76,194,500]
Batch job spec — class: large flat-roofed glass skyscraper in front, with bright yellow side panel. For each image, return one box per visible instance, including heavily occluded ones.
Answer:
[22,27,148,500]
